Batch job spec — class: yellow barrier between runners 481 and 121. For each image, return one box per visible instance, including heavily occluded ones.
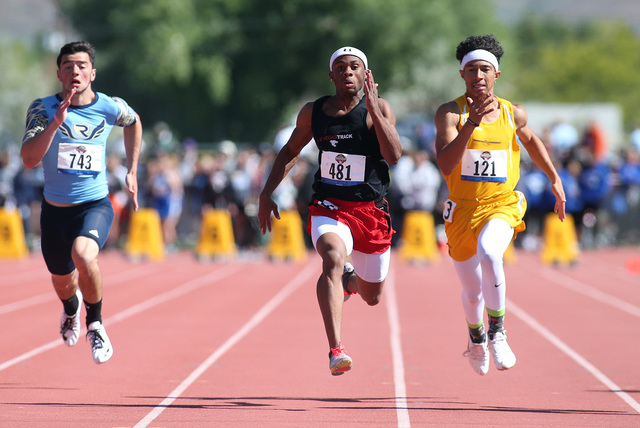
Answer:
[400,211,440,262]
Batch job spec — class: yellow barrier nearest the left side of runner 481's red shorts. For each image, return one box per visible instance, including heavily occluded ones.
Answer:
[267,211,307,262]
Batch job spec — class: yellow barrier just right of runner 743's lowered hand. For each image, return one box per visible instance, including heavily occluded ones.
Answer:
[125,208,164,260]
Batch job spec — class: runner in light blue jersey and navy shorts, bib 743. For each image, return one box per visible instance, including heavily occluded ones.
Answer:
[21,41,142,363]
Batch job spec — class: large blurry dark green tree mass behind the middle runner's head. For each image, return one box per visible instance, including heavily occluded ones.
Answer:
[61,0,495,142]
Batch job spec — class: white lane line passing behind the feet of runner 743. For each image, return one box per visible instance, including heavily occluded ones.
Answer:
[0,266,242,372]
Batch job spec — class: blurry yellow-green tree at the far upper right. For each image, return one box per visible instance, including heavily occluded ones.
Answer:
[514,19,640,130]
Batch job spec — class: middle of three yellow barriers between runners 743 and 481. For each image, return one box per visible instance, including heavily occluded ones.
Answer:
[196,210,237,258]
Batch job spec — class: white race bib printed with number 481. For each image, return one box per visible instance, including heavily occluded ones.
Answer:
[320,152,367,186]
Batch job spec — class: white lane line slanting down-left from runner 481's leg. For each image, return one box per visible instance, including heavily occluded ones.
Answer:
[134,261,316,428]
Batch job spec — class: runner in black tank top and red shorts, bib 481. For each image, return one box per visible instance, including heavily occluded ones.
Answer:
[258,46,402,376]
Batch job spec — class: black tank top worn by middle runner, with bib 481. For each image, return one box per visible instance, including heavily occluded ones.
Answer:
[311,96,390,201]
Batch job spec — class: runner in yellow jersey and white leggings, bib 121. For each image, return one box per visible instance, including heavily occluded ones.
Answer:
[435,35,566,375]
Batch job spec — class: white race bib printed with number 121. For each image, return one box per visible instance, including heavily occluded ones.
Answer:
[460,149,507,183]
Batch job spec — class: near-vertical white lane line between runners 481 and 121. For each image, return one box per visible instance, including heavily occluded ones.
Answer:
[385,271,411,428]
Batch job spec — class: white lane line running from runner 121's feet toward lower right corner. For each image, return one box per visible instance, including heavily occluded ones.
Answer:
[507,299,640,413]
